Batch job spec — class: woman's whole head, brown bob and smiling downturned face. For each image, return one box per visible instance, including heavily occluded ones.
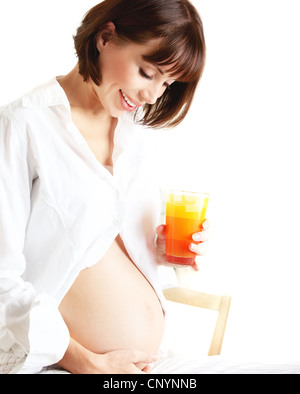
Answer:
[74,0,206,128]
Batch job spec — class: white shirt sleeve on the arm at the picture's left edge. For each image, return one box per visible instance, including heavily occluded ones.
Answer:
[0,113,70,373]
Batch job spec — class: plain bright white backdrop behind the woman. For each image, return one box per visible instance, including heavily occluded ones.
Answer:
[0,0,300,360]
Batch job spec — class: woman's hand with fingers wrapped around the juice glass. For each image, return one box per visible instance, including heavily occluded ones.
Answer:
[156,220,210,271]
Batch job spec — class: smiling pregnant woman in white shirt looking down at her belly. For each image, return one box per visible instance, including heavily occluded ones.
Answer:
[0,0,207,373]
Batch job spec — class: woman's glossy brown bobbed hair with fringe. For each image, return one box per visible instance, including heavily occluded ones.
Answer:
[74,0,206,127]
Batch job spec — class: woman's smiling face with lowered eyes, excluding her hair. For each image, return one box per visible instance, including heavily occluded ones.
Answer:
[94,37,174,117]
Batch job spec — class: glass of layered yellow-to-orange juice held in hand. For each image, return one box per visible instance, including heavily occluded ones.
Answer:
[166,190,209,265]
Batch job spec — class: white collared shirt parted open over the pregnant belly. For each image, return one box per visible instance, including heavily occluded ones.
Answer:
[0,79,163,373]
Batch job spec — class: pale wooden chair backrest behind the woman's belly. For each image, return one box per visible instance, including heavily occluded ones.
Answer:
[164,287,231,356]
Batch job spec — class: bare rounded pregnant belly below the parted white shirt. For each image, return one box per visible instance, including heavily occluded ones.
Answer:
[60,237,164,353]
